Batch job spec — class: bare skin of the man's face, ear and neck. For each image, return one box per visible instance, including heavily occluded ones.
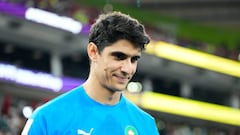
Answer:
[83,40,141,105]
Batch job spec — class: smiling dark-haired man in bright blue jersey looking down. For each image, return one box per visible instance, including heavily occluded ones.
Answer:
[22,12,159,135]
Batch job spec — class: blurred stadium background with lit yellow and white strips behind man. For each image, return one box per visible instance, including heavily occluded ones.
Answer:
[0,0,240,135]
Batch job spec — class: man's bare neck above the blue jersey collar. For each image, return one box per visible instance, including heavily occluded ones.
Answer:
[83,78,121,105]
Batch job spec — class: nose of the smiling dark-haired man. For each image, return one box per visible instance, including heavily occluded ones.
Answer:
[121,59,136,74]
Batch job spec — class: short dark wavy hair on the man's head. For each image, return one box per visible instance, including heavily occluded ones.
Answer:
[89,11,150,52]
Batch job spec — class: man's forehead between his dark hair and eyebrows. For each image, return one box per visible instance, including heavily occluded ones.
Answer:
[103,39,142,56]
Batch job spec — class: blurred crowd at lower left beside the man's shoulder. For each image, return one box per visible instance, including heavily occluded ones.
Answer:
[0,95,50,135]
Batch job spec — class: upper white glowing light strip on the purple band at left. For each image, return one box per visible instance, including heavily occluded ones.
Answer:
[25,8,82,34]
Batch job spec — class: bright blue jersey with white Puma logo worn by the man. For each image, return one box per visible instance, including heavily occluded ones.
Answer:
[22,86,159,135]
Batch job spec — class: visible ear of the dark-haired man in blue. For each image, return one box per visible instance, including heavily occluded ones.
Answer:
[87,42,98,61]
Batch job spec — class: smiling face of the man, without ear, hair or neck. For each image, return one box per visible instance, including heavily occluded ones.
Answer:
[94,40,141,91]
